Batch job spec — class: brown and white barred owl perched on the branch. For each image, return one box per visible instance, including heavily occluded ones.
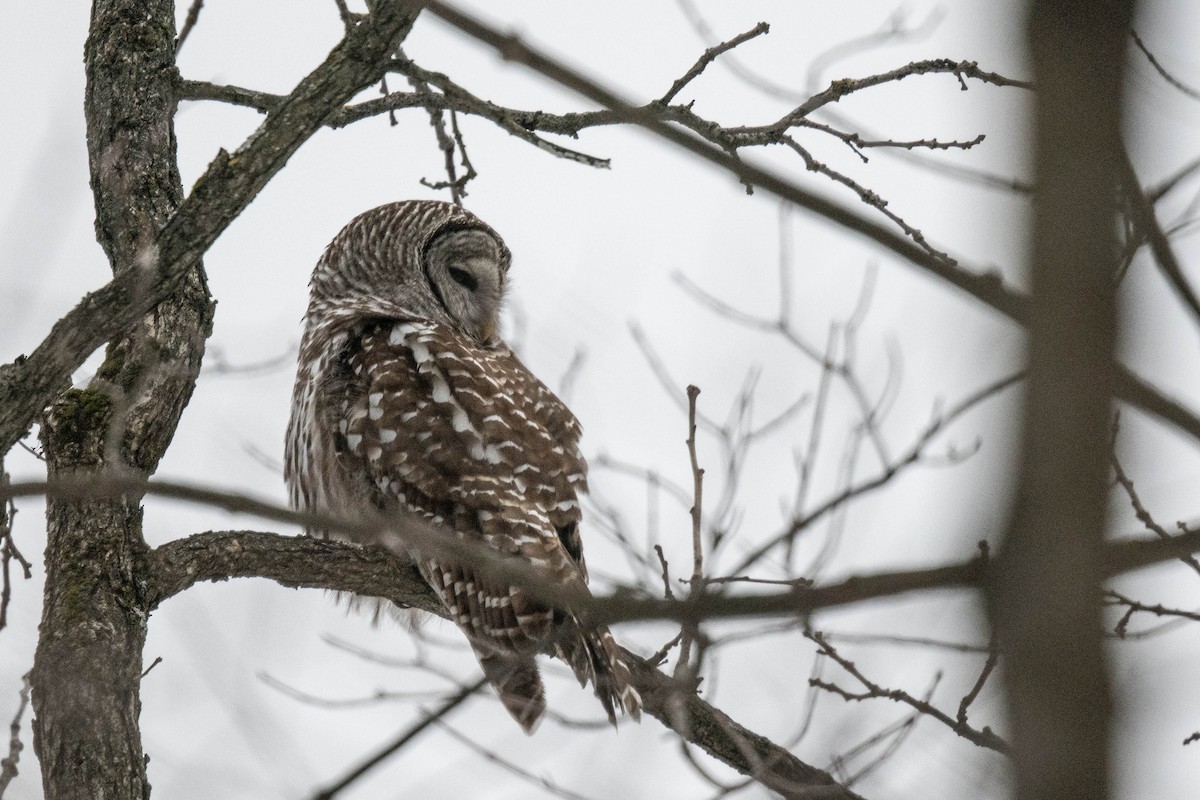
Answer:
[284,201,641,733]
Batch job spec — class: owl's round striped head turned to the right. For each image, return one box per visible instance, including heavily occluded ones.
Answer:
[310,200,511,344]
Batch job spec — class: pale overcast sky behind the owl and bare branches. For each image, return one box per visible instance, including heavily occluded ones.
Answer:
[0,0,1200,800]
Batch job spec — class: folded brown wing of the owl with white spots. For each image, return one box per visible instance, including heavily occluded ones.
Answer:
[341,321,587,633]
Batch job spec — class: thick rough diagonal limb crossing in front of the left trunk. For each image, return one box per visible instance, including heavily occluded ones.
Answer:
[0,0,414,453]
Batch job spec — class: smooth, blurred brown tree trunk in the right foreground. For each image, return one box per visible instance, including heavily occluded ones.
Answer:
[990,0,1134,800]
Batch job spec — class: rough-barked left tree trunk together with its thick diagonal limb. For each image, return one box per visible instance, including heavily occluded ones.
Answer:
[25,0,441,800]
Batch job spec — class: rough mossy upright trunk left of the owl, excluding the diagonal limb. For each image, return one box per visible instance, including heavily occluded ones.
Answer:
[32,0,212,800]
